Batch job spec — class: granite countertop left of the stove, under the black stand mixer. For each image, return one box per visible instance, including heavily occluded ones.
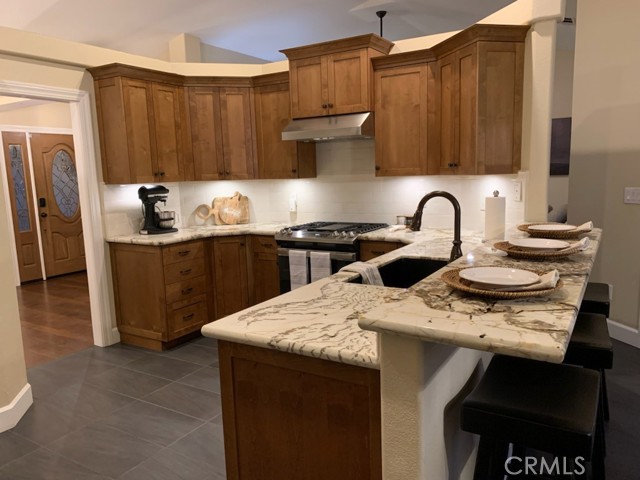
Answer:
[105,223,287,246]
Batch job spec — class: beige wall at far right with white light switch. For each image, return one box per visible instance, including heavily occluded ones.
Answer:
[569,0,640,328]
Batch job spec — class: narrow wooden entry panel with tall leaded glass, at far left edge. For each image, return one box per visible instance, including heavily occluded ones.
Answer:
[2,132,42,282]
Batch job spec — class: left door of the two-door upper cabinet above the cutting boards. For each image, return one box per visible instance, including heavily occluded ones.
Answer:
[189,87,224,180]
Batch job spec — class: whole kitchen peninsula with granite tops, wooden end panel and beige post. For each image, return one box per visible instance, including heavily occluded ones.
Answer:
[202,229,601,480]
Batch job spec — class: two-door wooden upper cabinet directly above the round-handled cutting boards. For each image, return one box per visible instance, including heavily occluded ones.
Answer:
[188,86,256,180]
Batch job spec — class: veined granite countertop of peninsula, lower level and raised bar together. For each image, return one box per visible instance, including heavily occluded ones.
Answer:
[202,227,601,368]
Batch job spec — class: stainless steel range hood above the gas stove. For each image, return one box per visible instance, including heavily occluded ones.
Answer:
[282,112,373,142]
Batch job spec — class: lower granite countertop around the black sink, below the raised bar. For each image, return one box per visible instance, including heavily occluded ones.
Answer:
[202,226,481,368]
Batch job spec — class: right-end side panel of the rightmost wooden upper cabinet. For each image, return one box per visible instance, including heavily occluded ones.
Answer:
[476,42,524,174]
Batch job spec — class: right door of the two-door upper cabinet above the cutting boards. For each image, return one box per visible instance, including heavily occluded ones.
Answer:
[220,87,255,180]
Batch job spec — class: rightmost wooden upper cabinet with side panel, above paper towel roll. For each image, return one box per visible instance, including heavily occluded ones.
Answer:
[429,25,528,175]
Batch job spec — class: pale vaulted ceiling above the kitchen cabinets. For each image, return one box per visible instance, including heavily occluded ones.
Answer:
[0,0,513,62]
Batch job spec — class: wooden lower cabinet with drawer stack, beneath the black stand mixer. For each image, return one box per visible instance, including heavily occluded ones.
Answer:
[110,240,211,350]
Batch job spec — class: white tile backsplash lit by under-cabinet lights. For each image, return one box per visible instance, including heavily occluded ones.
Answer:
[102,140,526,234]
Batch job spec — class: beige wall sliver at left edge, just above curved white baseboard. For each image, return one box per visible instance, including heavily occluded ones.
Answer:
[0,169,27,411]
